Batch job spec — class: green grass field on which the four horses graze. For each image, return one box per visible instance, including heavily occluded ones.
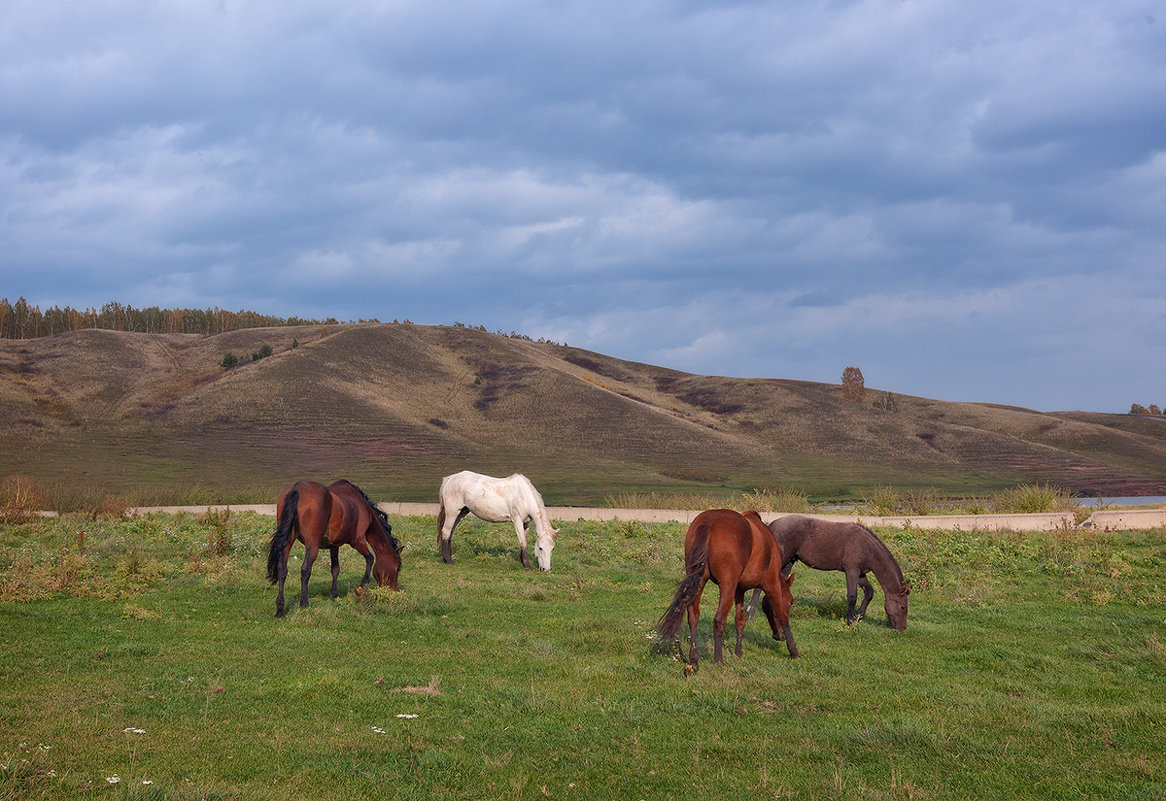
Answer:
[0,514,1166,800]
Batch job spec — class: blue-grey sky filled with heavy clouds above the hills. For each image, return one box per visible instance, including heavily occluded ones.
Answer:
[0,0,1166,412]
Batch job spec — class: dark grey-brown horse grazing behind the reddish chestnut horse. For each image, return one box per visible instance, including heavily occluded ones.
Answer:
[750,514,911,631]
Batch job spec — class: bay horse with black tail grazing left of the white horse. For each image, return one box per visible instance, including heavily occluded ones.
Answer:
[267,479,401,618]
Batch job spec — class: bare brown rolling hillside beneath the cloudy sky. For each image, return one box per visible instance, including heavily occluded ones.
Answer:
[0,324,1166,504]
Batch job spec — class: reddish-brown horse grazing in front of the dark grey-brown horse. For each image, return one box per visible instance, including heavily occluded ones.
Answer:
[658,510,798,670]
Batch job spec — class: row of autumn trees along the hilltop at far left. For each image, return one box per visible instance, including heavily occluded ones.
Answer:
[0,297,345,339]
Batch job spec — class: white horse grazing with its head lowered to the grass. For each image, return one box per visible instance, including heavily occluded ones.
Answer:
[437,470,559,570]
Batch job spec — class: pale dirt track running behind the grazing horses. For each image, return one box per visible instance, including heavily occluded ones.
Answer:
[120,503,1166,532]
